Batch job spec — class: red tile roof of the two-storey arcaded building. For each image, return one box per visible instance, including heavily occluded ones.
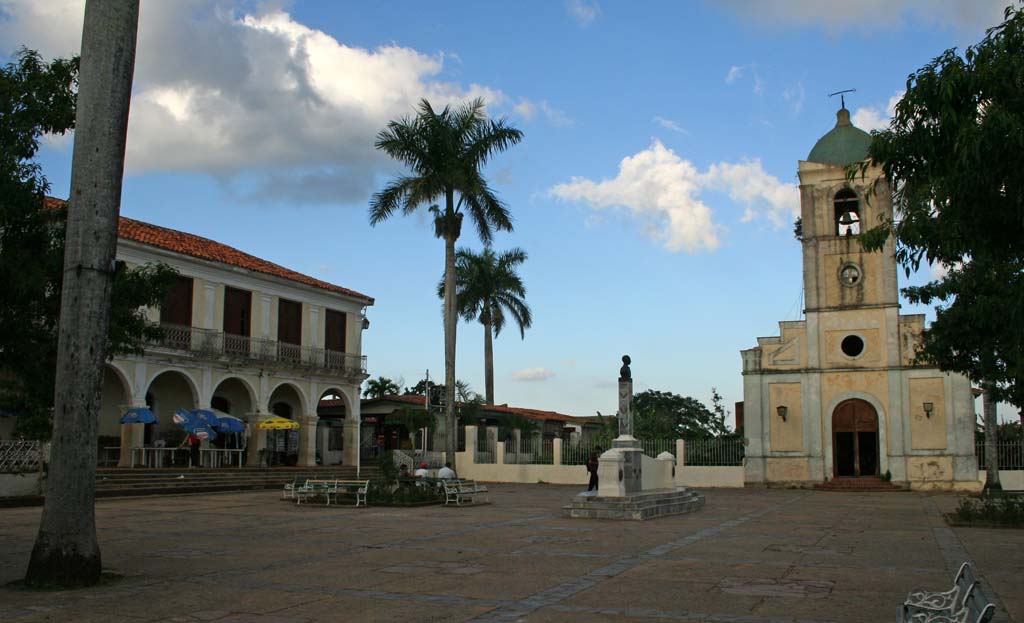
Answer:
[46,197,374,304]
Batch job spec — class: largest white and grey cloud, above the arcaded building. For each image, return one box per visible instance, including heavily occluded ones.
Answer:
[0,0,516,203]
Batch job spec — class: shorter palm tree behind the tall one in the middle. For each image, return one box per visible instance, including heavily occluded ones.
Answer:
[437,248,534,405]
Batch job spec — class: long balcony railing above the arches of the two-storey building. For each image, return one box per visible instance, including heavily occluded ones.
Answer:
[150,325,367,374]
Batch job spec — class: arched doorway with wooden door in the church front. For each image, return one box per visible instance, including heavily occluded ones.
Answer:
[833,399,879,476]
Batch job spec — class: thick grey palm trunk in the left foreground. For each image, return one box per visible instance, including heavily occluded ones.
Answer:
[25,0,138,587]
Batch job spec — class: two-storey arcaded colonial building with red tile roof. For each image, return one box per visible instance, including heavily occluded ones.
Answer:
[79,201,374,465]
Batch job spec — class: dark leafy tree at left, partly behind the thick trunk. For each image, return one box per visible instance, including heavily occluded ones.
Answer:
[0,49,176,439]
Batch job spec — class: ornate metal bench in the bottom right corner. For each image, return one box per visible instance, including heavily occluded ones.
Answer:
[896,563,995,623]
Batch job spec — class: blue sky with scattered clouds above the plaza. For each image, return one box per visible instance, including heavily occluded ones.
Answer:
[0,0,1016,428]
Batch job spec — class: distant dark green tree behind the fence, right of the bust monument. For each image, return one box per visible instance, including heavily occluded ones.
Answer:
[633,389,729,440]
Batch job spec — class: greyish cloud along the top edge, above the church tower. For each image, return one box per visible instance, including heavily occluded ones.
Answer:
[720,0,1009,32]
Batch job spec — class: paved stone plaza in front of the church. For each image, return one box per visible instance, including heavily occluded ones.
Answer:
[0,485,1024,623]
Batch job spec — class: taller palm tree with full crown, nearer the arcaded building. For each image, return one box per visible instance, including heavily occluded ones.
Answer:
[370,99,522,462]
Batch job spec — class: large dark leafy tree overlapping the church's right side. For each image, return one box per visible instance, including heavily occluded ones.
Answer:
[848,7,1024,408]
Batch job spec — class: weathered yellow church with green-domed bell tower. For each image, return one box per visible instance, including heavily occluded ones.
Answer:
[741,106,979,489]
